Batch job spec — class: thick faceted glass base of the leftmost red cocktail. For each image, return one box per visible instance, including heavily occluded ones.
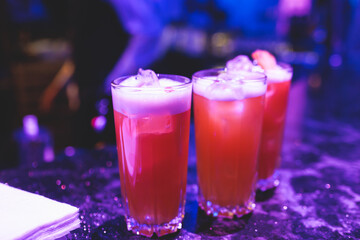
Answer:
[126,213,184,237]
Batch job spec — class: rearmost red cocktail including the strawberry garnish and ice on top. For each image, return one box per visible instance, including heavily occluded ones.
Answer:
[226,50,292,191]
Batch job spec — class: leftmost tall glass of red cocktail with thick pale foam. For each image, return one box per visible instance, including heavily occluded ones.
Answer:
[112,70,192,236]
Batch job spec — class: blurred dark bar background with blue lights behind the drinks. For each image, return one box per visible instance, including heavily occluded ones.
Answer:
[0,0,360,169]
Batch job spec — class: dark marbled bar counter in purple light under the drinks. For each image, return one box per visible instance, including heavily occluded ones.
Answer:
[0,68,360,239]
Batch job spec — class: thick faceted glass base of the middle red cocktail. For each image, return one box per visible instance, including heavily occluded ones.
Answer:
[198,194,256,219]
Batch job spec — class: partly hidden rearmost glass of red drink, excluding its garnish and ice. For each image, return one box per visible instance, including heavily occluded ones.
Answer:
[258,64,292,191]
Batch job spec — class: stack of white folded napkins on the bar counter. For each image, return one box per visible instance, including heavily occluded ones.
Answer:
[0,183,80,240]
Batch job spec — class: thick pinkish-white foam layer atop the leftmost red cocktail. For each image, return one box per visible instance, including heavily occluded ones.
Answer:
[111,75,191,115]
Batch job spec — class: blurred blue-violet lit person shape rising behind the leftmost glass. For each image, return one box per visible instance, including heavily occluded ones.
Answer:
[104,0,183,94]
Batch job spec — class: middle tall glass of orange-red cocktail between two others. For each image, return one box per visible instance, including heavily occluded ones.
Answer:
[193,69,266,218]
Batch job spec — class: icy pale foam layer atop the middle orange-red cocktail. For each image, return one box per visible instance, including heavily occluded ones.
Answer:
[193,70,266,101]
